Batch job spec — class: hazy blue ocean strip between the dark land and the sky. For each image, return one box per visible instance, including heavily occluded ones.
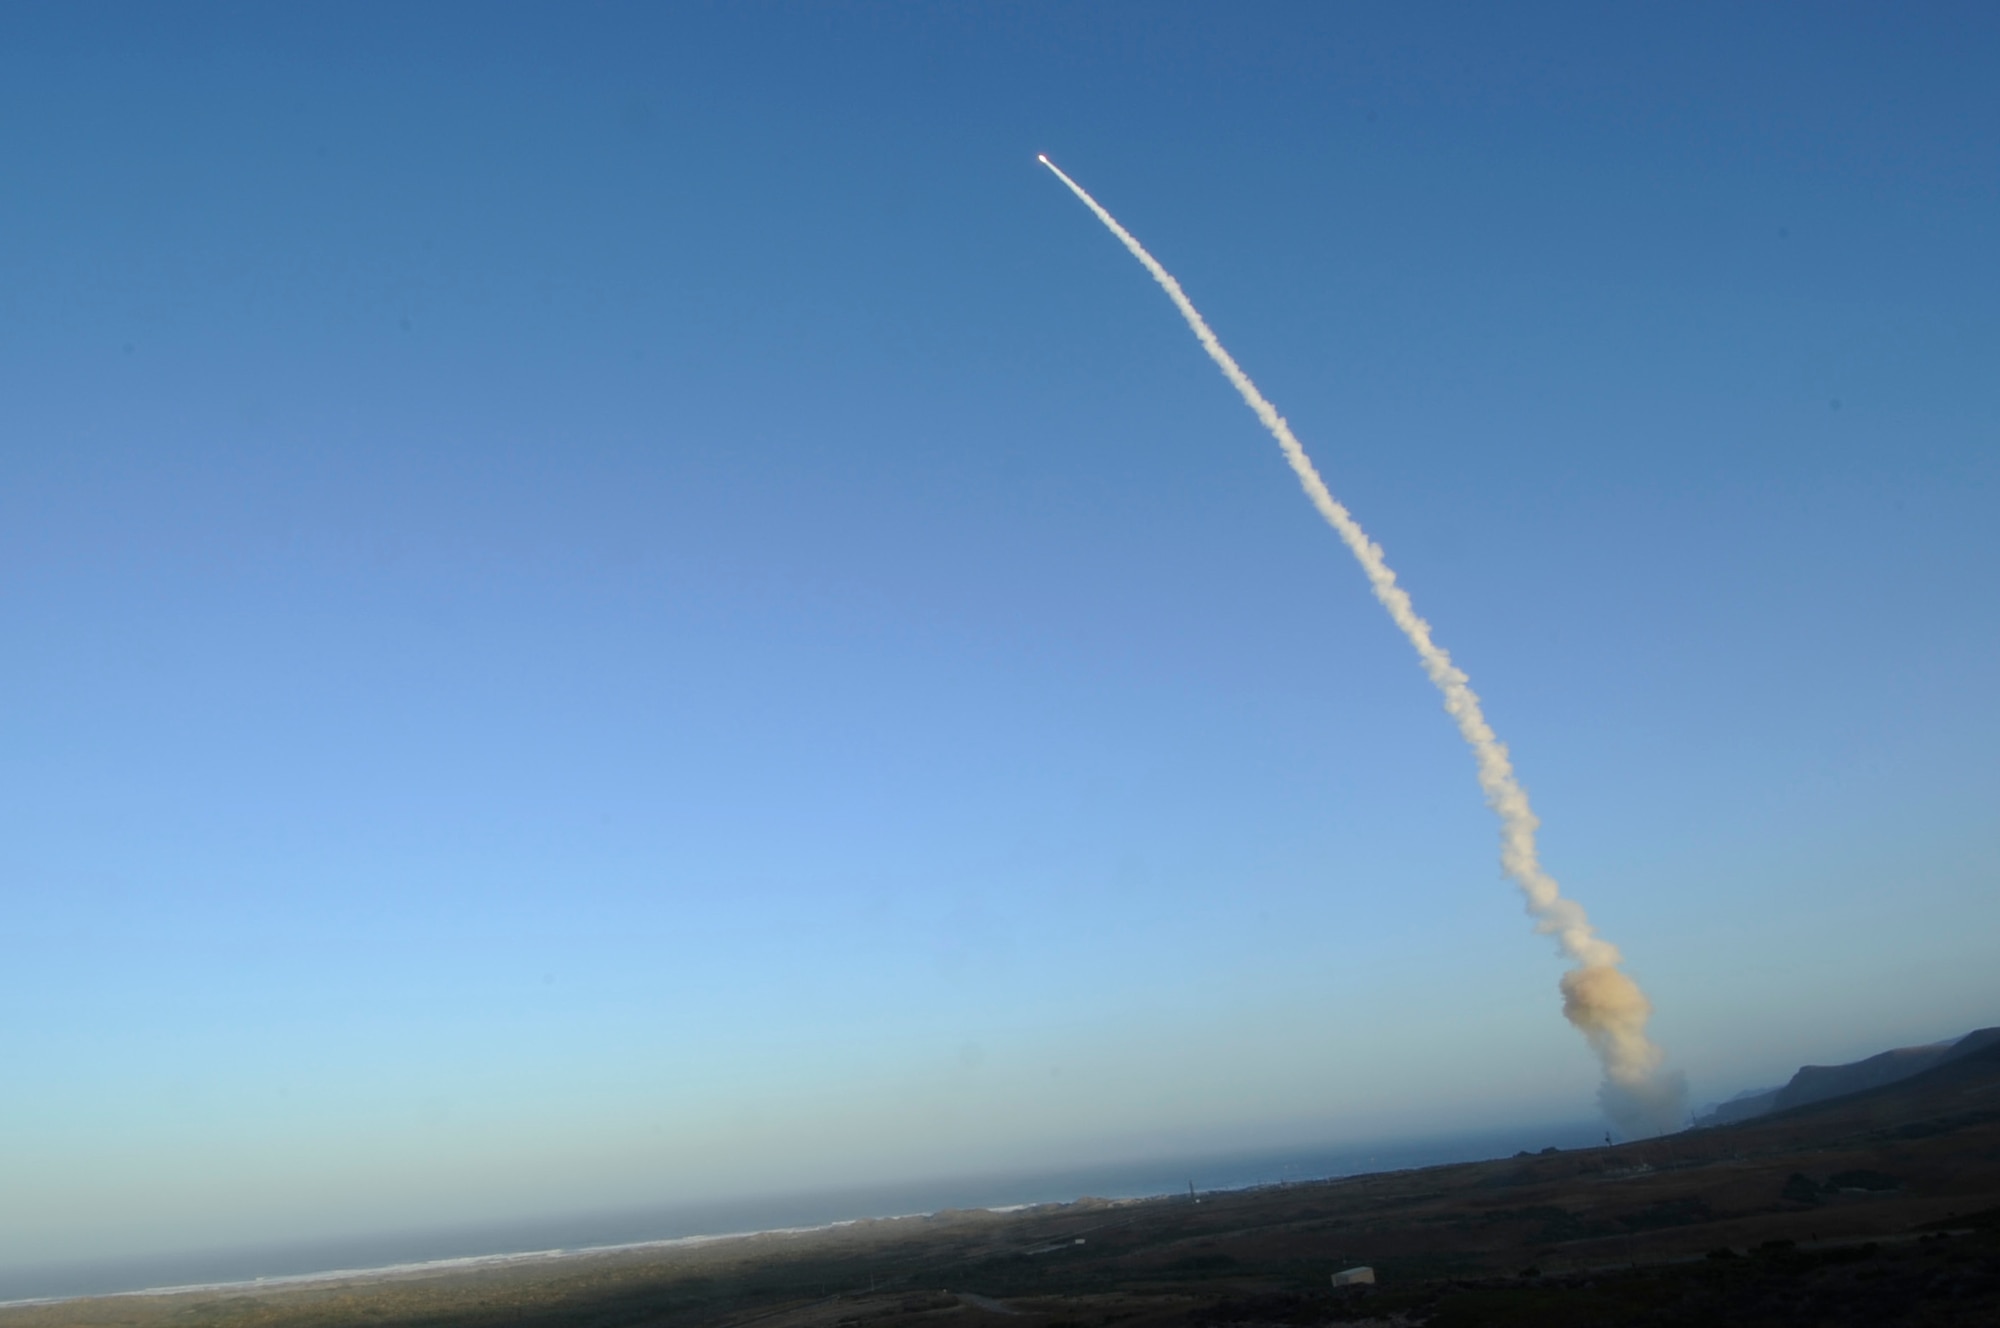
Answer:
[0,1122,1604,1302]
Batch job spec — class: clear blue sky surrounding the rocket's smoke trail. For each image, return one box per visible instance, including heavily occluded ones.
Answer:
[0,2,2000,1262]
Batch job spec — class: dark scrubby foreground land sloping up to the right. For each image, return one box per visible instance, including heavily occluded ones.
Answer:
[15,1046,2000,1328]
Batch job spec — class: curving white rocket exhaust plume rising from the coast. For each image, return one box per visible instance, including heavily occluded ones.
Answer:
[1036,156,1686,1134]
